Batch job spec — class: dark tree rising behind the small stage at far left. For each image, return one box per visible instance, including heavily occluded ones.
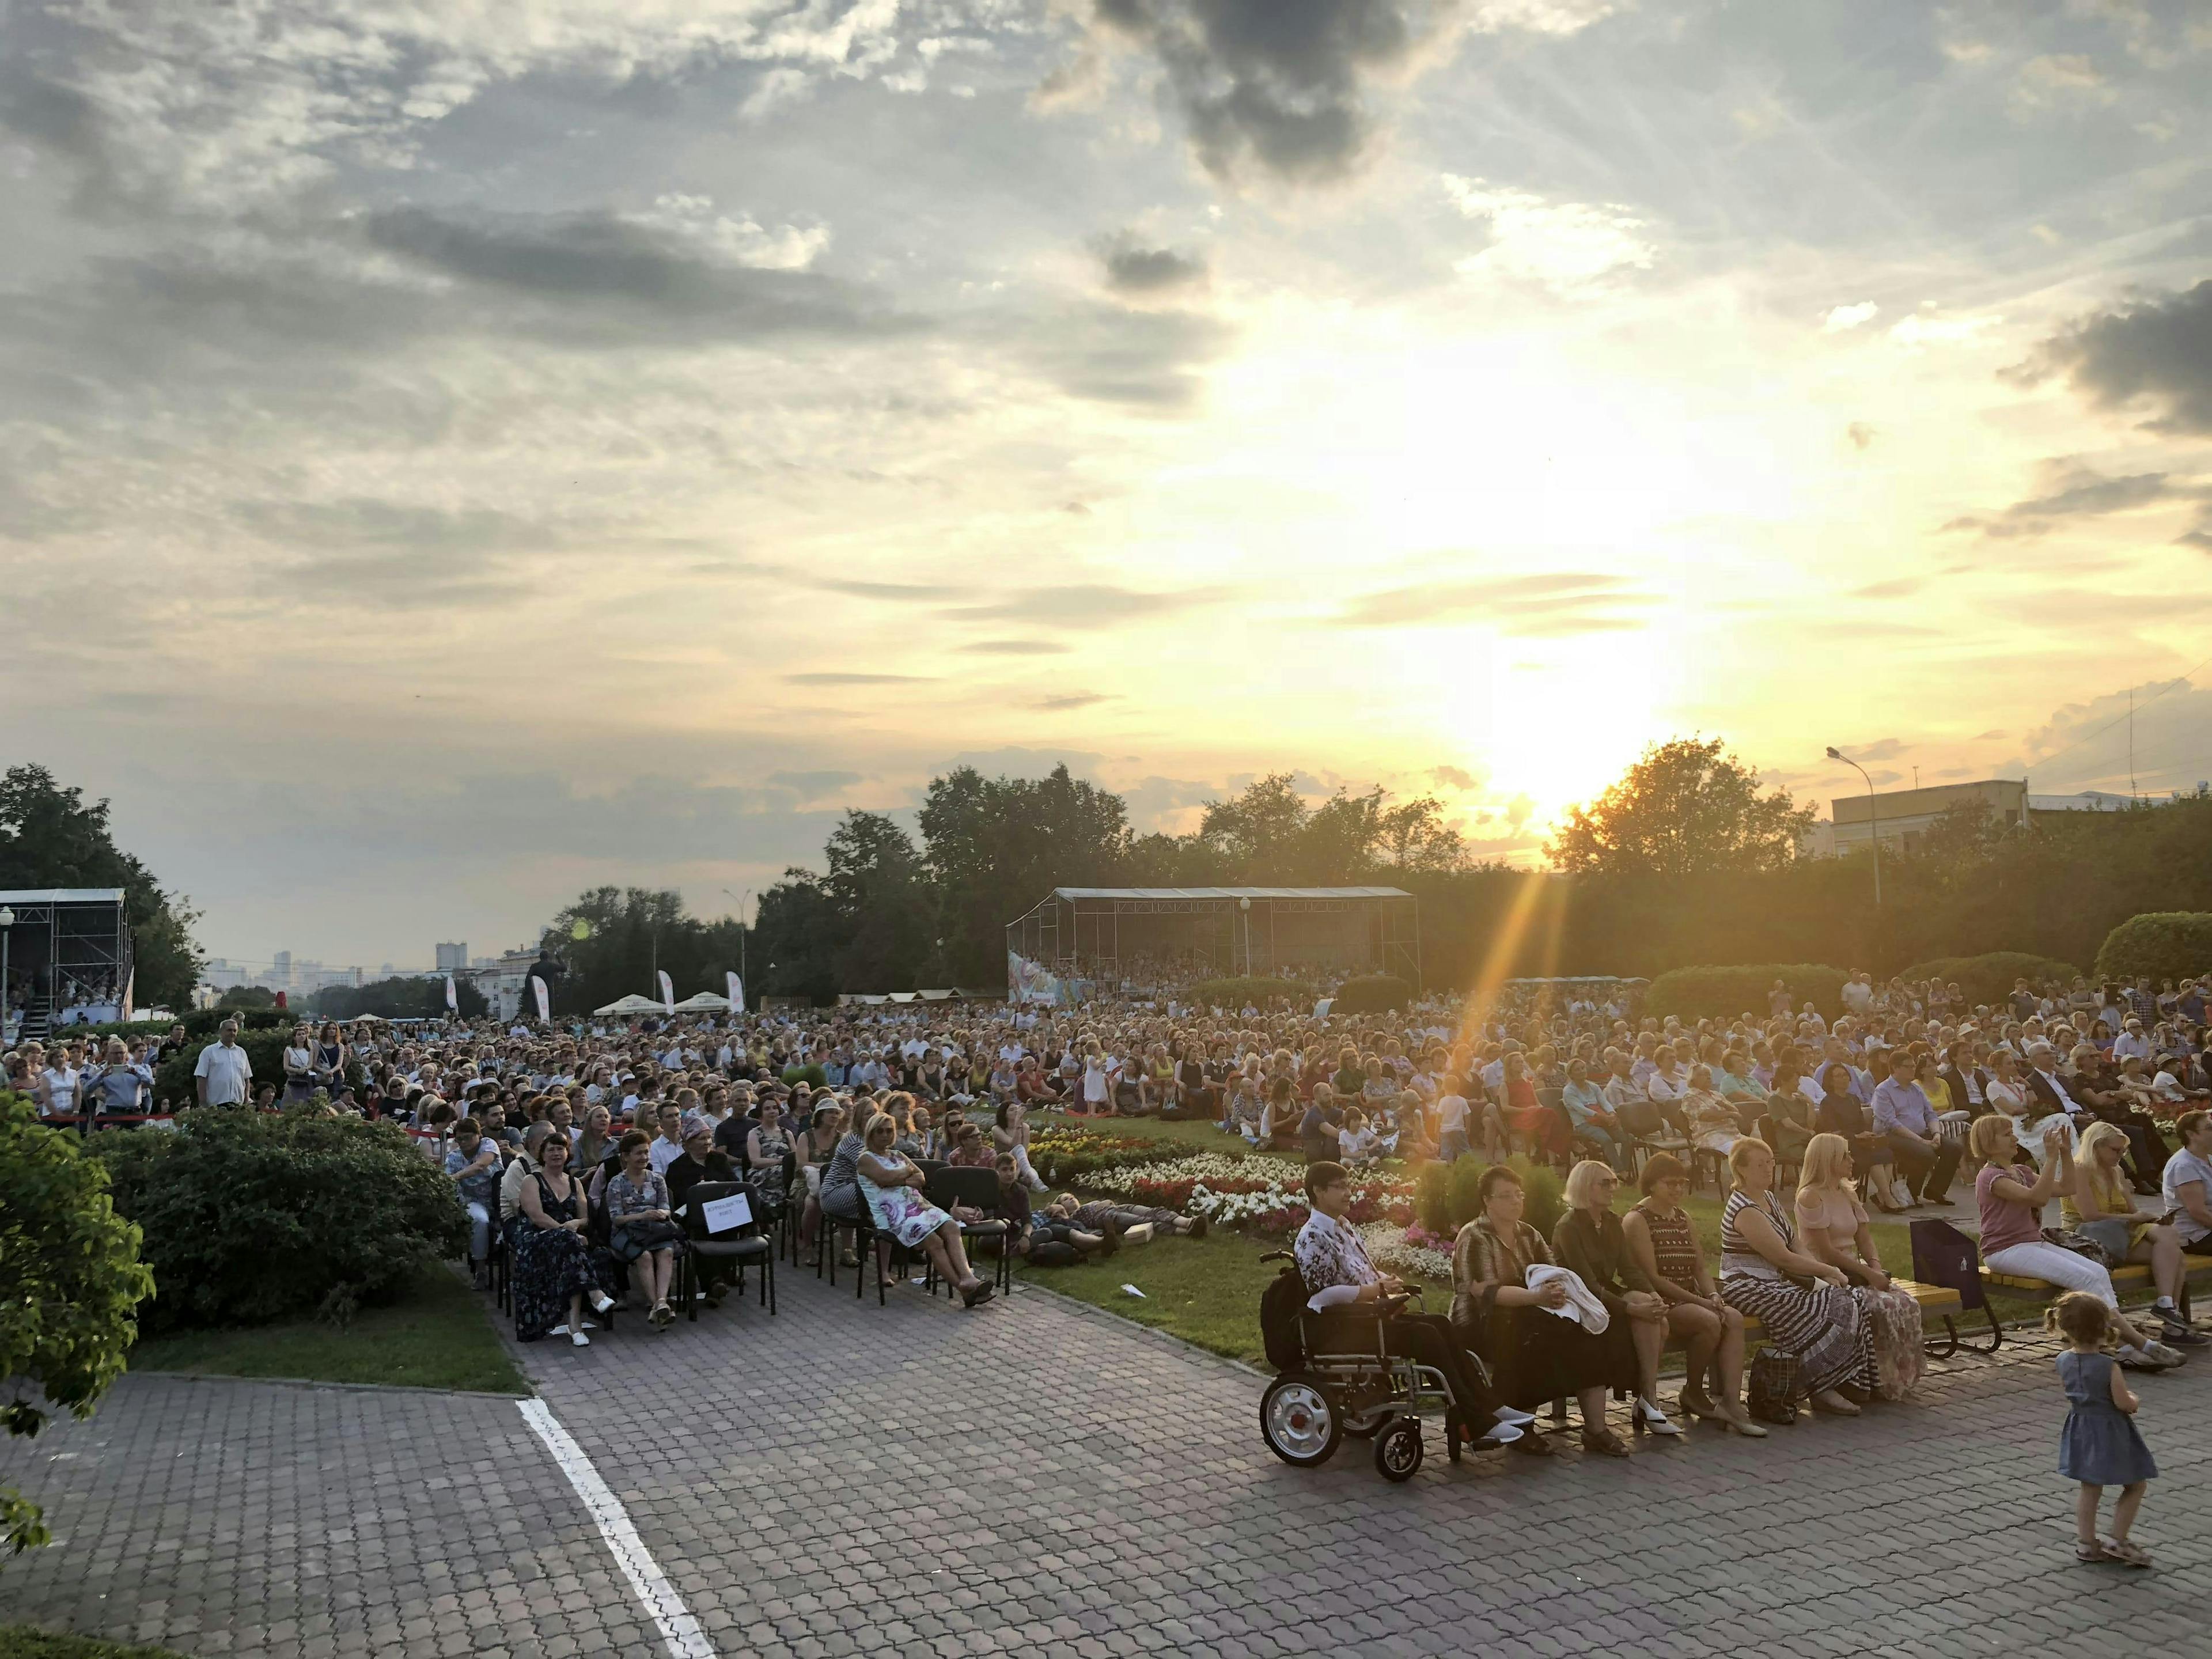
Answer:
[0,766,203,1009]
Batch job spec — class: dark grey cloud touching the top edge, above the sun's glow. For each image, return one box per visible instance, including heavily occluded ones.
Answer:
[1095,0,1451,184]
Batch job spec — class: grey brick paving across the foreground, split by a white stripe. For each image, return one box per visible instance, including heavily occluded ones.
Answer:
[0,1245,2212,1659]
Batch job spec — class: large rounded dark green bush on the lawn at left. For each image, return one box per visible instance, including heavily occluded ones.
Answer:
[89,1108,469,1332]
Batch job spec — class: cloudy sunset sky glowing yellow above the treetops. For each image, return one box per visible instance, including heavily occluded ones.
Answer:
[0,0,2212,964]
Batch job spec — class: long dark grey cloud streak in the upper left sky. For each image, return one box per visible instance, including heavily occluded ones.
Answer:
[361,208,918,343]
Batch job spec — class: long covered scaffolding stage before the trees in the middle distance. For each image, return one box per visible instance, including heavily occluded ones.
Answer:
[1006,887,1420,1002]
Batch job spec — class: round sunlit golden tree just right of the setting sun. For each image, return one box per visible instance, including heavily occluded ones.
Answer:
[1551,737,1814,878]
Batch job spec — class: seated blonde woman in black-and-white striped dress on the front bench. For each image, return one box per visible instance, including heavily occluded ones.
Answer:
[1721,1135,1880,1418]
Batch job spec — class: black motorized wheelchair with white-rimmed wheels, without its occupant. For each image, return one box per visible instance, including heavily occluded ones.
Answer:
[1259,1250,1460,1480]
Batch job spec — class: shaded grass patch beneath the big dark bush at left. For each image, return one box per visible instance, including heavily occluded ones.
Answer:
[128,1263,529,1397]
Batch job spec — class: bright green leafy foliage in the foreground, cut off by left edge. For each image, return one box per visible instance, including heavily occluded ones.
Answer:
[0,1093,153,1553]
